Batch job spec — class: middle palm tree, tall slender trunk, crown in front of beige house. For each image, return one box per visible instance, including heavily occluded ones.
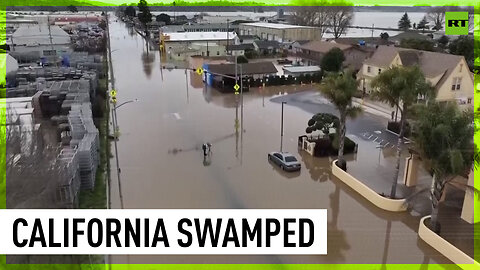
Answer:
[371,66,433,198]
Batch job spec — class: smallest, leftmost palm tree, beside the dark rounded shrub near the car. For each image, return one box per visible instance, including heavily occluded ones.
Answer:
[319,71,362,170]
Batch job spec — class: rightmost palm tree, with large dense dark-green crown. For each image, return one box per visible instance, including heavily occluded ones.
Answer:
[408,103,478,232]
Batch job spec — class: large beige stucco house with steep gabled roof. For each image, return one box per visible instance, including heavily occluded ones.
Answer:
[357,46,474,108]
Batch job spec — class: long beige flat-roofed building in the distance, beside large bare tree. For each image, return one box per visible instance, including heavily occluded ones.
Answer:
[239,22,321,42]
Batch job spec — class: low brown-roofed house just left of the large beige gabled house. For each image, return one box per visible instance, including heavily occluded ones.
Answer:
[297,40,372,70]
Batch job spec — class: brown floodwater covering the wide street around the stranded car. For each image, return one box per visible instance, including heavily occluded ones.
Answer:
[110,16,450,269]
